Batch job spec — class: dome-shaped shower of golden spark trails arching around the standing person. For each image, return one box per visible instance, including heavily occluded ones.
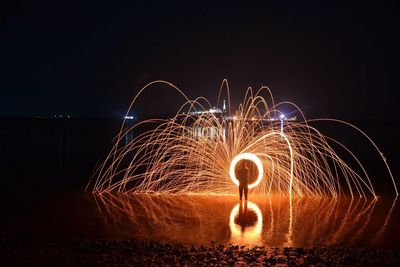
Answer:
[88,80,397,198]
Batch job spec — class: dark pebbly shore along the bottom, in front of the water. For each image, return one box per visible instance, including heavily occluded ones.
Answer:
[0,237,400,266]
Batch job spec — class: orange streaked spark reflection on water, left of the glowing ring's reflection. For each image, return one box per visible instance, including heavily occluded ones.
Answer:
[93,193,228,243]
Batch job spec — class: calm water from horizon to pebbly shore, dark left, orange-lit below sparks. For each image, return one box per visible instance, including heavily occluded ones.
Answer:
[0,120,400,247]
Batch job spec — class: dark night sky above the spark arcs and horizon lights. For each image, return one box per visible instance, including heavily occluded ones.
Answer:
[0,0,400,119]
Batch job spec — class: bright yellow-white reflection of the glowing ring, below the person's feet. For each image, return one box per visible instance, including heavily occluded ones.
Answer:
[229,201,263,245]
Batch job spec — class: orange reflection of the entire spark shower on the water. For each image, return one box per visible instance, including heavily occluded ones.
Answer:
[93,193,396,247]
